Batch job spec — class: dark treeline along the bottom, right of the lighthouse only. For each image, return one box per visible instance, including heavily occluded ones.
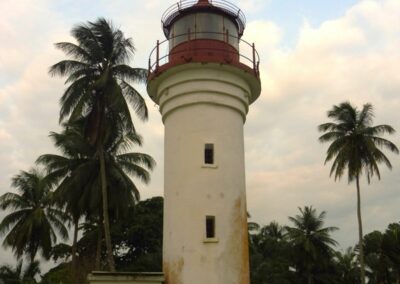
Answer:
[249,207,400,284]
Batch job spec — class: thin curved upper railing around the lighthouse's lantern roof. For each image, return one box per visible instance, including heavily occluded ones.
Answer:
[161,0,246,35]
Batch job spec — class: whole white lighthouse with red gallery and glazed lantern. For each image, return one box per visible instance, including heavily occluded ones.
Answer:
[148,0,261,284]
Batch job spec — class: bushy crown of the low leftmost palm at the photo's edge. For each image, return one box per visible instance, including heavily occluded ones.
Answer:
[0,169,68,263]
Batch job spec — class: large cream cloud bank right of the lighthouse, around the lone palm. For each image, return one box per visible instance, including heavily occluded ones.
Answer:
[245,1,400,247]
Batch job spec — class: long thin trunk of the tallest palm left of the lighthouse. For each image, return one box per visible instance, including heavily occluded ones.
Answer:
[99,145,115,272]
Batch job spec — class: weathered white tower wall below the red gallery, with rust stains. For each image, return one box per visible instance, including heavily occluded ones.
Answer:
[149,64,257,284]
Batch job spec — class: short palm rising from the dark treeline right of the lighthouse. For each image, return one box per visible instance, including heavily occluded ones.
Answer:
[285,206,337,284]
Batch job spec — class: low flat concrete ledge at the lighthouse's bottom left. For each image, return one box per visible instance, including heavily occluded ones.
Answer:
[88,271,165,284]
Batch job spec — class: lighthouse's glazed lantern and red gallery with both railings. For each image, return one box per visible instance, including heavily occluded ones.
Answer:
[149,0,259,79]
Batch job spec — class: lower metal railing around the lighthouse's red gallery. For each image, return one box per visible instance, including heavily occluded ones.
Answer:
[148,32,260,76]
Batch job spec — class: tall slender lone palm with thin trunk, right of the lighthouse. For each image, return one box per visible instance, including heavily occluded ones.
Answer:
[318,102,399,284]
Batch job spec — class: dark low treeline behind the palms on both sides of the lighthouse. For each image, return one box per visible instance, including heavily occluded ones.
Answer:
[0,197,400,284]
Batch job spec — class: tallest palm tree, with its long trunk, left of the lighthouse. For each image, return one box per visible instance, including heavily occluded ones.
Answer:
[49,18,148,271]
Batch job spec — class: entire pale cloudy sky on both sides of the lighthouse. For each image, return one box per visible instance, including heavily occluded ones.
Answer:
[0,0,400,270]
